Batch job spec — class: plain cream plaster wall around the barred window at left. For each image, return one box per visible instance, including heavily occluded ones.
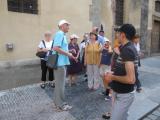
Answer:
[0,0,92,61]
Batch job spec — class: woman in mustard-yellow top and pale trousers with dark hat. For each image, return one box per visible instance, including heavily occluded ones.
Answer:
[85,32,102,90]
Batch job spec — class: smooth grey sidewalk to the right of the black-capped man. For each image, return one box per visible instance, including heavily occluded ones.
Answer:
[129,56,160,120]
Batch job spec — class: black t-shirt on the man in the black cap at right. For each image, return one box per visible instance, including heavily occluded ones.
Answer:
[110,42,138,93]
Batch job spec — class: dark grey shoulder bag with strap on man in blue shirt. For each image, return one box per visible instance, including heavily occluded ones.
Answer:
[46,38,64,69]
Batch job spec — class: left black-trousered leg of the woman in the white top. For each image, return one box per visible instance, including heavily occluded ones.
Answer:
[41,60,47,88]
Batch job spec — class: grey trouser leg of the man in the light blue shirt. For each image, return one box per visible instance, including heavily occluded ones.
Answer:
[54,67,66,107]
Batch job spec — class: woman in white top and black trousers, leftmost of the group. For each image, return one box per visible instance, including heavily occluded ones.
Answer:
[37,31,54,89]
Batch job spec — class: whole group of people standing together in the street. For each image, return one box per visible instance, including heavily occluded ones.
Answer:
[38,20,142,120]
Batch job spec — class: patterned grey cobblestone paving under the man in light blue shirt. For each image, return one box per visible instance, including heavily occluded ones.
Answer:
[0,77,111,120]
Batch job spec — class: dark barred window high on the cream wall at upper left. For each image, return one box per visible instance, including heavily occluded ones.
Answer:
[7,0,38,14]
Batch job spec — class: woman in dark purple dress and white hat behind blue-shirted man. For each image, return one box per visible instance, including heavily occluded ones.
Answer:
[67,34,80,86]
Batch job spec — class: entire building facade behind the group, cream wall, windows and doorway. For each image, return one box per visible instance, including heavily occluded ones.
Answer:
[0,0,160,61]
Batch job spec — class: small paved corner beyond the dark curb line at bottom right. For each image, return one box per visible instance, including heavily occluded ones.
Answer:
[140,105,160,120]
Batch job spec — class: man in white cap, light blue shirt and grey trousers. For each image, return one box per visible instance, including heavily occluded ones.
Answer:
[53,20,76,110]
